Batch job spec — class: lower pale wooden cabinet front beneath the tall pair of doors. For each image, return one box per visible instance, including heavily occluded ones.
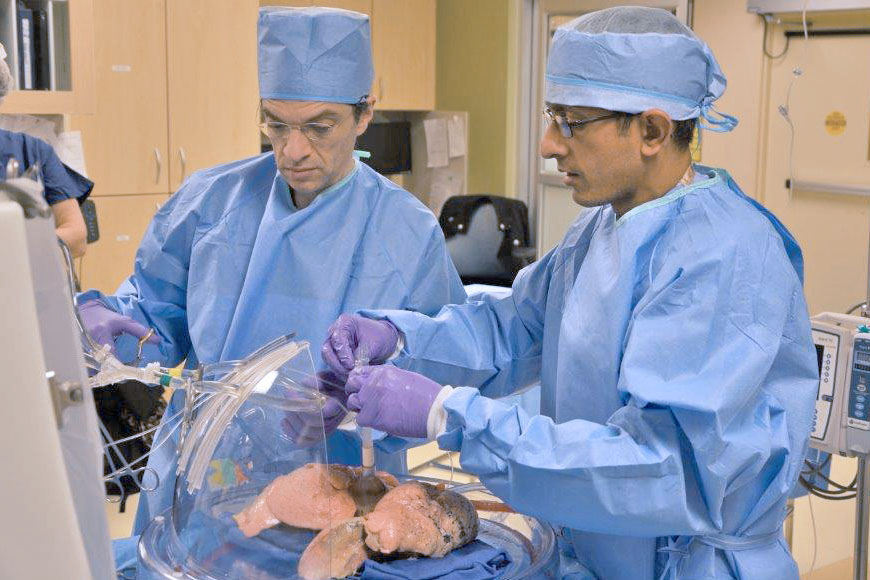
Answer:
[80,193,169,294]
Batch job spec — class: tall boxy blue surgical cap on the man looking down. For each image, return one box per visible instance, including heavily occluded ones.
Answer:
[257,7,374,105]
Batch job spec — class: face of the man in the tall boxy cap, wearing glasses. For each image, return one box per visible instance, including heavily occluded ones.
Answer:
[262,100,372,197]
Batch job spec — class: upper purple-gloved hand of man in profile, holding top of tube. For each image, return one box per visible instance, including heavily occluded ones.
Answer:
[321,314,399,375]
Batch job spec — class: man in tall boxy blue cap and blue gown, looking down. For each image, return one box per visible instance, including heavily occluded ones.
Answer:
[80,8,465,576]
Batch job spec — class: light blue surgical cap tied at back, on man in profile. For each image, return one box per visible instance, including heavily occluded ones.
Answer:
[545,6,737,132]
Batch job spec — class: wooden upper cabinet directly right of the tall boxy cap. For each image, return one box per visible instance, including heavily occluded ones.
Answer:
[260,0,436,111]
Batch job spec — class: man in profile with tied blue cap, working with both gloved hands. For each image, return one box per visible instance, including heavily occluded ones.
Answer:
[323,7,818,580]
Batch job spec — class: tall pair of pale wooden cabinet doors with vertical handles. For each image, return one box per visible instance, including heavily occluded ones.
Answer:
[70,0,260,196]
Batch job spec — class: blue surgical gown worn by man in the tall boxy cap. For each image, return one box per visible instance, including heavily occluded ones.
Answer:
[80,153,465,534]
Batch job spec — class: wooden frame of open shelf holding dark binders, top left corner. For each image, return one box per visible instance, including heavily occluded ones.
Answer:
[0,0,95,115]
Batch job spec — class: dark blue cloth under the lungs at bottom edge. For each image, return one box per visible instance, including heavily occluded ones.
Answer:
[355,540,511,580]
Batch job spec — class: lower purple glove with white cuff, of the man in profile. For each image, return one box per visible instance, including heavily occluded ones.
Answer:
[345,365,441,438]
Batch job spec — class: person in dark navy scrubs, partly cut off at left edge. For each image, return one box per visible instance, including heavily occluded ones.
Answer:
[0,44,94,258]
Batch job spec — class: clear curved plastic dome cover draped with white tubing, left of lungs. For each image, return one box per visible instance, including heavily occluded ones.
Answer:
[139,339,338,579]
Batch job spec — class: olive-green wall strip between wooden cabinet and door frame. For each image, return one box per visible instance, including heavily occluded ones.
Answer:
[435,0,515,195]
